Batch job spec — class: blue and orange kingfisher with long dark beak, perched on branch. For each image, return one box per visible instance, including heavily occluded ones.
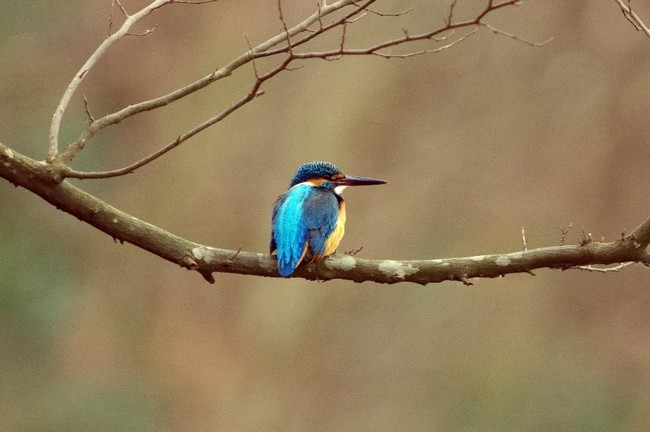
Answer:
[269,161,387,277]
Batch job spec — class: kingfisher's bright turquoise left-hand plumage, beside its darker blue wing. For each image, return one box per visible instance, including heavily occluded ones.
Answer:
[271,185,312,277]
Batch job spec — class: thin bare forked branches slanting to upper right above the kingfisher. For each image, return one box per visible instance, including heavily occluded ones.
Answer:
[55,0,546,179]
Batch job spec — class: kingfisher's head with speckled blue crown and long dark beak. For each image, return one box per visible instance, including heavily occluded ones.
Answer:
[289,161,386,193]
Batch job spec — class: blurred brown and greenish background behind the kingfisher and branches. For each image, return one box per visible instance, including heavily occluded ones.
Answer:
[0,0,650,430]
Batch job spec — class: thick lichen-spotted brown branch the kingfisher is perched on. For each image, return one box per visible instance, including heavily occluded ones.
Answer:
[0,144,650,284]
